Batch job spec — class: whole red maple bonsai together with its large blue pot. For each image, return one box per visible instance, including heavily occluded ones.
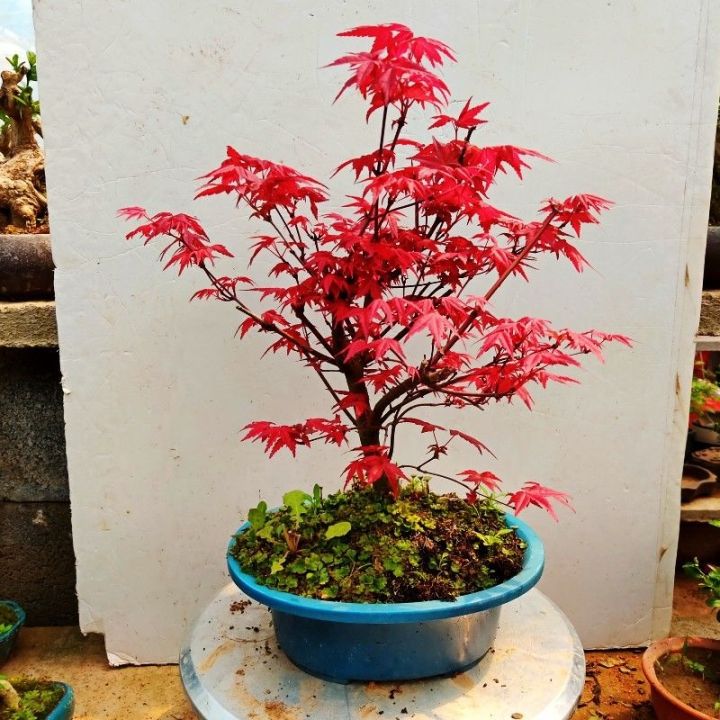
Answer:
[121,24,629,681]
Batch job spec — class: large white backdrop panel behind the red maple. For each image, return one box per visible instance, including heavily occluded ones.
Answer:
[35,0,720,664]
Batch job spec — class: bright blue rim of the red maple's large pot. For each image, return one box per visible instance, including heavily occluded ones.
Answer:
[227,513,545,624]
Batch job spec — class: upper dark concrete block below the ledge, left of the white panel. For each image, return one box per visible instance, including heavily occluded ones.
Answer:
[0,348,69,502]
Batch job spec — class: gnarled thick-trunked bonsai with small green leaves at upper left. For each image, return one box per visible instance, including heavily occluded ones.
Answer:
[0,51,47,232]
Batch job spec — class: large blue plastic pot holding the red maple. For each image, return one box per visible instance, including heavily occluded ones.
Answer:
[227,515,544,683]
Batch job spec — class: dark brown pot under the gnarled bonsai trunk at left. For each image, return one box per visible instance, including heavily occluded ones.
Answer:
[0,234,55,300]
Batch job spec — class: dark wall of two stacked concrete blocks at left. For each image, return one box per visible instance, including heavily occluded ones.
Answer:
[0,347,77,625]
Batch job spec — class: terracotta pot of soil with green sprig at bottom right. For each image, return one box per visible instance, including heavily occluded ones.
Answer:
[642,560,720,720]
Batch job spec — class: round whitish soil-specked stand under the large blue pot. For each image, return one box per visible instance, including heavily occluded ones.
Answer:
[180,585,585,720]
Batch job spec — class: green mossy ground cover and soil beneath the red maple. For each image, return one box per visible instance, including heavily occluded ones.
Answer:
[231,483,525,602]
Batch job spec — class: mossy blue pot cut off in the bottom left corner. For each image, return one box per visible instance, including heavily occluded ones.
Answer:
[0,675,75,720]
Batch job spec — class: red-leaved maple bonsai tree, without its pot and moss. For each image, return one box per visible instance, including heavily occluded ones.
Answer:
[120,24,628,516]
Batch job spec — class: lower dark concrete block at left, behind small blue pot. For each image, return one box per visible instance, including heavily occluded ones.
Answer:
[0,502,77,625]
